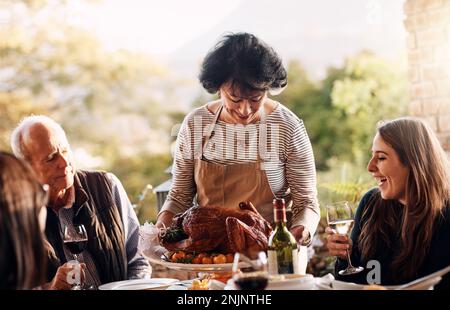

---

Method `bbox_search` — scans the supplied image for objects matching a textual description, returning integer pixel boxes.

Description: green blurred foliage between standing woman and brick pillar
[277,52,407,170]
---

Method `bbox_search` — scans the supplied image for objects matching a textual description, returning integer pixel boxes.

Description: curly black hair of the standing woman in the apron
[199,33,287,94]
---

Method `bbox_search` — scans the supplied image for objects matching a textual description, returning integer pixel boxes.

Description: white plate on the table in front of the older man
[98,278,179,290]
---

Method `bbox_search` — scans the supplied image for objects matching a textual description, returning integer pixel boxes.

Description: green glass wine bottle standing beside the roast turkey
[268,199,299,274]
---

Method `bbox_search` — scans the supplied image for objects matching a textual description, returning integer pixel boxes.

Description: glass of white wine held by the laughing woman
[327,201,364,275]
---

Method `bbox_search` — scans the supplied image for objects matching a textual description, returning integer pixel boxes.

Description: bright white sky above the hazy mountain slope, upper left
[69,0,241,55]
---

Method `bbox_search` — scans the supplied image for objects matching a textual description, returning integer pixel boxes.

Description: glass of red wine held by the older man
[63,224,88,290]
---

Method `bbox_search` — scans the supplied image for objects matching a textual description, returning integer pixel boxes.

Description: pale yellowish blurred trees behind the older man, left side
[0,0,181,221]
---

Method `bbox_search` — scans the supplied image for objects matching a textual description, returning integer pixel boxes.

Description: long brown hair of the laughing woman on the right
[358,117,450,281]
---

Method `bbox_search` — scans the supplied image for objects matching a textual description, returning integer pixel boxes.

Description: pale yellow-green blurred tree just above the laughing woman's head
[330,51,408,163]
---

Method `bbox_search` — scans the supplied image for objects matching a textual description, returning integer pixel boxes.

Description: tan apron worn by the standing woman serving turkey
[194,105,308,274]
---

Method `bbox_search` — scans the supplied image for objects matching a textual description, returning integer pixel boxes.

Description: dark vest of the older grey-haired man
[45,170,127,283]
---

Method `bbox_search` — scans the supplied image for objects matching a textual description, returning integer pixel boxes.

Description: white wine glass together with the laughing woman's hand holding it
[326,201,364,275]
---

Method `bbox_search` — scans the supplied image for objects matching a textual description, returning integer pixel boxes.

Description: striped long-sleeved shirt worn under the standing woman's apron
[161,103,320,235]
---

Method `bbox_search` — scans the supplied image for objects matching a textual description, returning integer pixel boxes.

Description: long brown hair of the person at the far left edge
[0,152,48,289]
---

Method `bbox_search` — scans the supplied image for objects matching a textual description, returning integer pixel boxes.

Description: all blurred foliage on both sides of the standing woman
[0,0,408,228]
